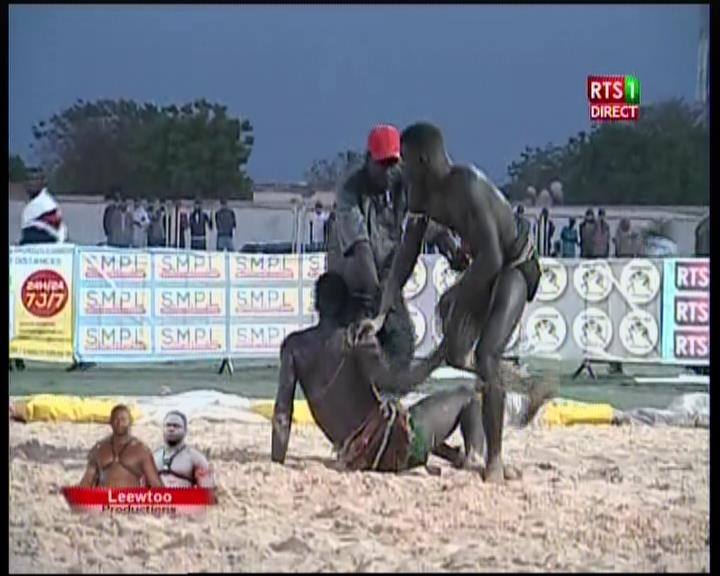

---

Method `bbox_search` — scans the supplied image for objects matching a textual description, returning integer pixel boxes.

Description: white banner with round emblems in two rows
[404,255,662,362]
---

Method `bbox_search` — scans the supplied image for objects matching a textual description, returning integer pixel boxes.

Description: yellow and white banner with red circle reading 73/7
[9,246,74,363]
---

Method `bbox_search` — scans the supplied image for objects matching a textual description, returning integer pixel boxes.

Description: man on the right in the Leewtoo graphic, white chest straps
[153,410,215,488]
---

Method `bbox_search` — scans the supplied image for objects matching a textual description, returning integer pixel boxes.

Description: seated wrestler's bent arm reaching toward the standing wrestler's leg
[355,336,444,394]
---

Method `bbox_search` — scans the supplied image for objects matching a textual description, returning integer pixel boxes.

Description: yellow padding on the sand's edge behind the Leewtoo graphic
[14,394,142,424]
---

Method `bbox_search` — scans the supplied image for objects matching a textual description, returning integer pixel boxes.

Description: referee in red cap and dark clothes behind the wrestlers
[328,124,461,369]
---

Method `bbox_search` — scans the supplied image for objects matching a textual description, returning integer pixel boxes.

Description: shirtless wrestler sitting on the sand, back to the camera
[272,272,483,472]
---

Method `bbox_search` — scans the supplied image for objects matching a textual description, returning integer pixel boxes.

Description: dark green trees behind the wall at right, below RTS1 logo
[506,100,710,205]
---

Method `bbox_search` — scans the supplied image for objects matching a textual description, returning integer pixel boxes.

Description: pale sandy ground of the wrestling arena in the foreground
[10,419,710,573]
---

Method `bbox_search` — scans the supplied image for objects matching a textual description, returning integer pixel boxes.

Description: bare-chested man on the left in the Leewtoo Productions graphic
[79,404,162,488]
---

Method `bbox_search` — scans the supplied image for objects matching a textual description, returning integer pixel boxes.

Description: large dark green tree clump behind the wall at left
[33,99,254,199]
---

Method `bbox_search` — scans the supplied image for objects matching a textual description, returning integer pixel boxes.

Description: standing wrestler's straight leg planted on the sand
[475,268,527,482]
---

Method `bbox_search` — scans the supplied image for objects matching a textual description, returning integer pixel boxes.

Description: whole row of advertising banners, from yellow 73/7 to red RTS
[9,246,688,364]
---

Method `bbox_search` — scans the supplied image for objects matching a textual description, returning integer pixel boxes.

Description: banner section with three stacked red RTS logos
[662,258,710,365]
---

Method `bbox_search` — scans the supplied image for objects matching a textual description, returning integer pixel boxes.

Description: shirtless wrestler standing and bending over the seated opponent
[366,123,541,482]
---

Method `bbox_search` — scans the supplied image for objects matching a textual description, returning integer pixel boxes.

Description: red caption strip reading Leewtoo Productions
[63,486,216,514]
